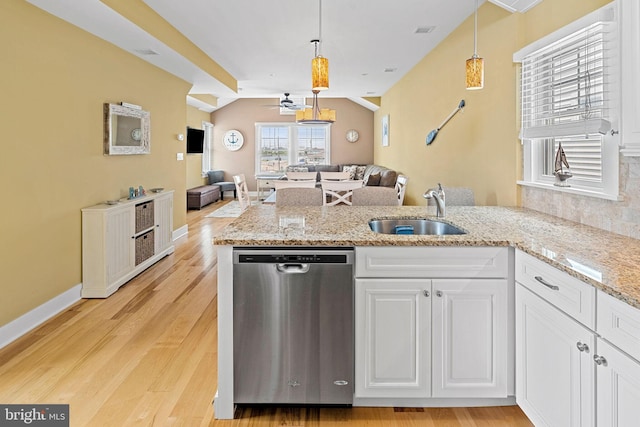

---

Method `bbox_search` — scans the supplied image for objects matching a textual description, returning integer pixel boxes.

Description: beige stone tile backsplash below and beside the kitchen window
[522,157,640,239]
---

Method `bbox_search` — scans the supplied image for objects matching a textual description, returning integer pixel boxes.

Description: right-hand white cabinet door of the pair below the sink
[432,279,508,397]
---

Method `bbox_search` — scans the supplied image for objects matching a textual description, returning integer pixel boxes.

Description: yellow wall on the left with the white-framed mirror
[0,0,190,325]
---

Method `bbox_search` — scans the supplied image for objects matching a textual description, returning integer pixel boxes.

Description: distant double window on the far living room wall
[256,123,331,174]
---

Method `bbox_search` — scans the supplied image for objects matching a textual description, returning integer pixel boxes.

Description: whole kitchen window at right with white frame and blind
[514,4,619,199]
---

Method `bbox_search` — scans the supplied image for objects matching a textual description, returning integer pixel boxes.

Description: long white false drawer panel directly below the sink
[356,246,509,279]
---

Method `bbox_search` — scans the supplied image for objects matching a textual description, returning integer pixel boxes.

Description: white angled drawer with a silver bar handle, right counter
[516,251,596,330]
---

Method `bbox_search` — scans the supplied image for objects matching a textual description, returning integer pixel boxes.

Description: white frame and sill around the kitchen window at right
[513,1,620,200]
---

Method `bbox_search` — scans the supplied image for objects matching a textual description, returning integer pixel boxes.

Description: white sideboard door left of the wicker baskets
[105,207,135,284]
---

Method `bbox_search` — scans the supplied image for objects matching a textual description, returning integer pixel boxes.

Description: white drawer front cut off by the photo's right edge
[596,290,640,360]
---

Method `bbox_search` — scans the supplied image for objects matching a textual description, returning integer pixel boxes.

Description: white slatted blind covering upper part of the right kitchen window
[520,22,615,140]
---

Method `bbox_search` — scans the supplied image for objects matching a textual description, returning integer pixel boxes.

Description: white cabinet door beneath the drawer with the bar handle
[516,284,595,427]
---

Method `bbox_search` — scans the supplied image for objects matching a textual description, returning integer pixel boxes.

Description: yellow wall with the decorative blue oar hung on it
[374,0,608,206]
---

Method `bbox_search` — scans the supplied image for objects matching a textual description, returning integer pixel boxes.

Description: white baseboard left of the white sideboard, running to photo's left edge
[0,284,82,348]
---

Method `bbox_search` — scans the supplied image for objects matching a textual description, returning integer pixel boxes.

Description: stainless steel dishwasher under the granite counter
[233,248,354,405]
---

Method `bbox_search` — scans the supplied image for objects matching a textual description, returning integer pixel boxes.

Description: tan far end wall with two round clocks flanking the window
[211,98,373,191]
